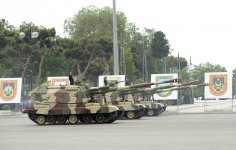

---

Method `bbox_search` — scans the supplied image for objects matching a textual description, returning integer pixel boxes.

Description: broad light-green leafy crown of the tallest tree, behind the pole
[64,6,127,41]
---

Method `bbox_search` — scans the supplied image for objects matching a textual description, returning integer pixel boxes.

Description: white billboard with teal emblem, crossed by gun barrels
[151,73,178,100]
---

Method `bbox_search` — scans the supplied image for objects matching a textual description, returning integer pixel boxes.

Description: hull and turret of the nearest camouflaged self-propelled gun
[23,83,119,125]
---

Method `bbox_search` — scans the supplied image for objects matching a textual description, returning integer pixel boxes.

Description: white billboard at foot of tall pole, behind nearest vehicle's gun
[98,75,125,87]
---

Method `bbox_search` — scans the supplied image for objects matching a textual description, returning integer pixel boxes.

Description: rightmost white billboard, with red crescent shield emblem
[205,72,232,99]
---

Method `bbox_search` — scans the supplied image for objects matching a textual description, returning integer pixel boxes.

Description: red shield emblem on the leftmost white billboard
[0,80,17,101]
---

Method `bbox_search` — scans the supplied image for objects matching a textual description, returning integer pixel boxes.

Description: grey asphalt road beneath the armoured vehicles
[0,114,236,150]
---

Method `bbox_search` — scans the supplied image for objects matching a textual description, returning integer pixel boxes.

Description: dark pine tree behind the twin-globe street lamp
[20,22,56,86]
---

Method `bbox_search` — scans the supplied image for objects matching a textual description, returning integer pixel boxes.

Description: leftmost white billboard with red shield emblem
[0,78,22,103]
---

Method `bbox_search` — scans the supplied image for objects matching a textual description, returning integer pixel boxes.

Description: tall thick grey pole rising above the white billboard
[113,0,120,75]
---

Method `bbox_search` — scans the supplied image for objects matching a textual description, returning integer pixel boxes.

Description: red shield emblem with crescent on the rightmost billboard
[209,74,227,96]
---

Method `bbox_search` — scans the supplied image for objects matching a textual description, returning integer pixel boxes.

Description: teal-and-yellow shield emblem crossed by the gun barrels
[156,76,173,97]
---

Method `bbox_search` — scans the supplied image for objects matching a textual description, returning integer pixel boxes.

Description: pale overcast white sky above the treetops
[0,0,236,72]
